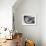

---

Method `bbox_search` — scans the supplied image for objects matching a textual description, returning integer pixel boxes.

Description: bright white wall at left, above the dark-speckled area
[0,0,16,29]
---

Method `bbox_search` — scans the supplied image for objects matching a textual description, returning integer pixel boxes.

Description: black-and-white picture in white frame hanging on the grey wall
[22,15,36,25]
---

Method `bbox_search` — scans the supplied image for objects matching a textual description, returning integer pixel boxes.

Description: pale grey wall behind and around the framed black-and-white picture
[13,0,41,46]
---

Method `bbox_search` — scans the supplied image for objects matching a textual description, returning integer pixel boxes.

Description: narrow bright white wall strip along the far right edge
[40,0,46,46]
